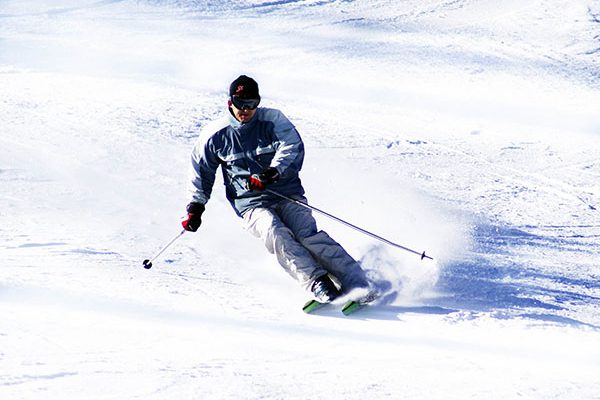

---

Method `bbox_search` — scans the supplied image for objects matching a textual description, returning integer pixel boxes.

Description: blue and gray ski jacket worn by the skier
[189,107,304,216]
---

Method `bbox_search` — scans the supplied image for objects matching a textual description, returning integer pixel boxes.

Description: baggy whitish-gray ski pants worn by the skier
[243,197,368,291]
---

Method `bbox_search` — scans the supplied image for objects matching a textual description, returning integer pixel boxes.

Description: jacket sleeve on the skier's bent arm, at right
[270,112,304,176]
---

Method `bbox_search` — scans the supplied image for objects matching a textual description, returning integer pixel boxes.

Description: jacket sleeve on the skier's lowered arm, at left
[188,134,219,204]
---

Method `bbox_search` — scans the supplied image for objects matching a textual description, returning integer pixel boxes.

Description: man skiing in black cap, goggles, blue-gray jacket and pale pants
[182,75,369,303]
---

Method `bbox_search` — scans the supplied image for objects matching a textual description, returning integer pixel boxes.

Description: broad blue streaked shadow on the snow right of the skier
[426,226,600,329]
